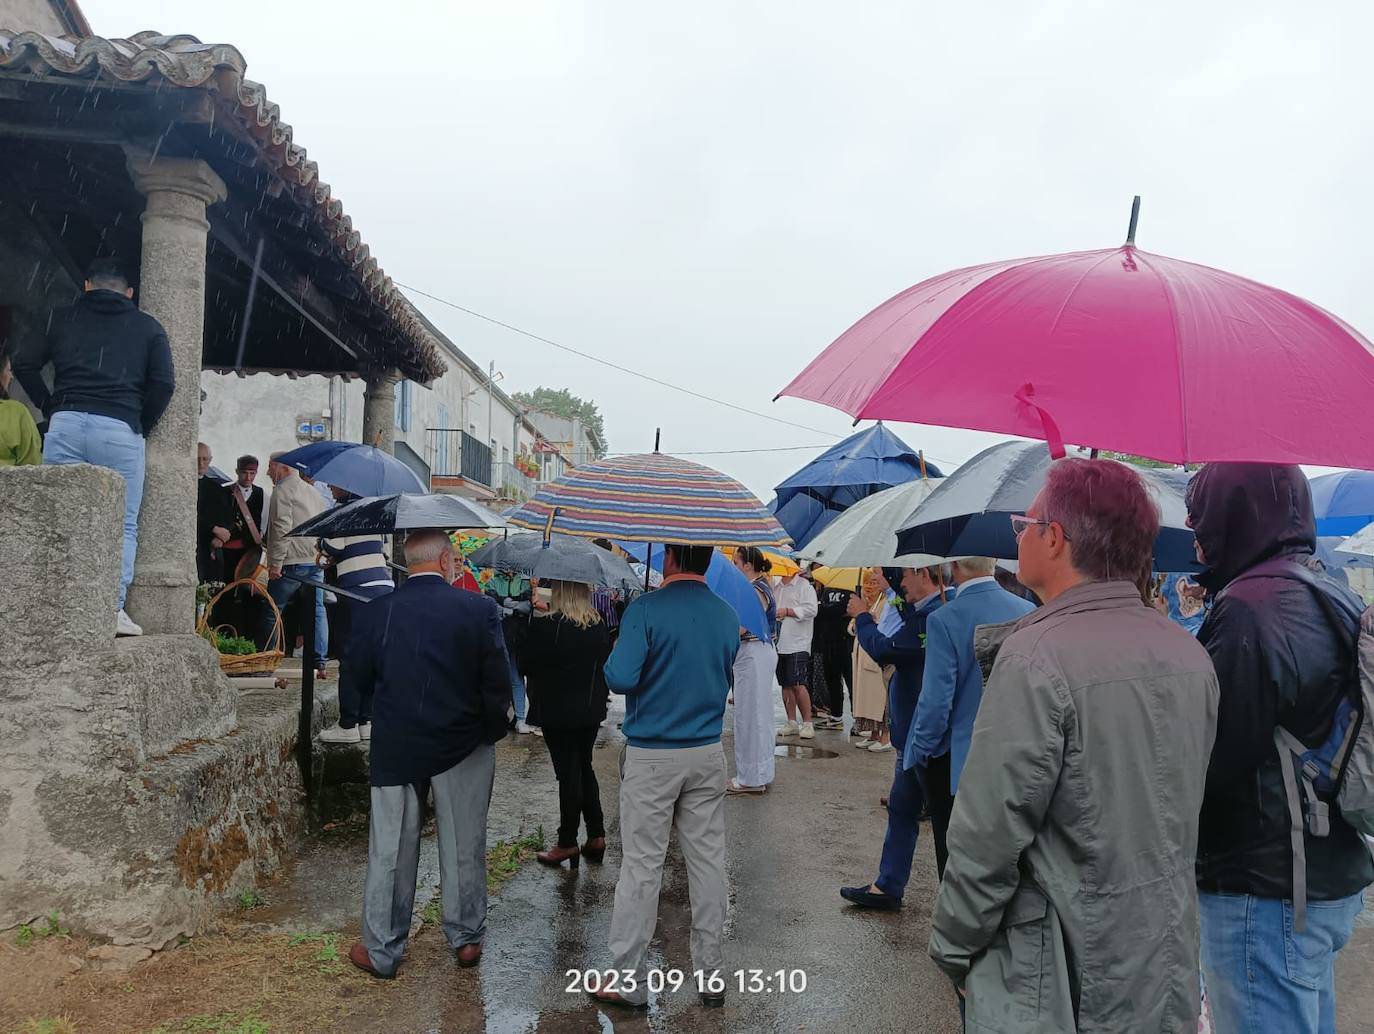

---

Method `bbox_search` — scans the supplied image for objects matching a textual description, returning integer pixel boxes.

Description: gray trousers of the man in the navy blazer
[363,743,496,974]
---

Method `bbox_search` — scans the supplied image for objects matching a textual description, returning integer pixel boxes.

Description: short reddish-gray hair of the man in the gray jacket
[1039,459,1160,582]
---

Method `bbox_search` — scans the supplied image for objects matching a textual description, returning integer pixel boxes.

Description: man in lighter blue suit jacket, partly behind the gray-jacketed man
[903,556,1035,879]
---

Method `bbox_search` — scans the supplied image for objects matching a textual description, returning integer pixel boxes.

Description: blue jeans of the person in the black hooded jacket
[1198,894,1364,1034]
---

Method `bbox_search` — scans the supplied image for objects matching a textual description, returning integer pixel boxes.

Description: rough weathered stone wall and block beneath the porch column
[0,466,330,947]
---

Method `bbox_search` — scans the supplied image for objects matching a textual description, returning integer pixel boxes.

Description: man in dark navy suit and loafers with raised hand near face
[840,564,949,912]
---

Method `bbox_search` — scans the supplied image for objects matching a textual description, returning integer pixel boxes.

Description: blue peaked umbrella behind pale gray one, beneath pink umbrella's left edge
[774,423,944,548]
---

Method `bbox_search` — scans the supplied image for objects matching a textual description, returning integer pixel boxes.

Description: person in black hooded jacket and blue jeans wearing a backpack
[1187,463,1374,1034]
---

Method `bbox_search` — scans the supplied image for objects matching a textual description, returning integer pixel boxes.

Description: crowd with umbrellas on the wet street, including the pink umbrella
[190,205,1374,1031]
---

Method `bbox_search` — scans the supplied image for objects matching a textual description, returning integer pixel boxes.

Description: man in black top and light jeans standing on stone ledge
[14,258,174,636]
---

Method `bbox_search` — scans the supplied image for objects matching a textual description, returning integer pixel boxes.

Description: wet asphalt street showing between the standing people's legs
[247,694,1374,1034]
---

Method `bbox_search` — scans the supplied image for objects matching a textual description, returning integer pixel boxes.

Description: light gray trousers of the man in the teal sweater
[610,743,728,1002]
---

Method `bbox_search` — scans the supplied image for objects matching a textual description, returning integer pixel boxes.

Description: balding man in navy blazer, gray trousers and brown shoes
[349,531,511,978]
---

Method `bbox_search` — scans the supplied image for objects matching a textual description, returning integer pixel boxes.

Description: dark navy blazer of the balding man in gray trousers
[349,575,511,787]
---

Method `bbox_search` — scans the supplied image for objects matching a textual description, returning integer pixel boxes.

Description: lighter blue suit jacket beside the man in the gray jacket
[903,582,1035,794]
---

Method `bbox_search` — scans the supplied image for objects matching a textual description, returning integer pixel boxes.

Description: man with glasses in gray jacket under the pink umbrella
[930,460,1219,1034]
